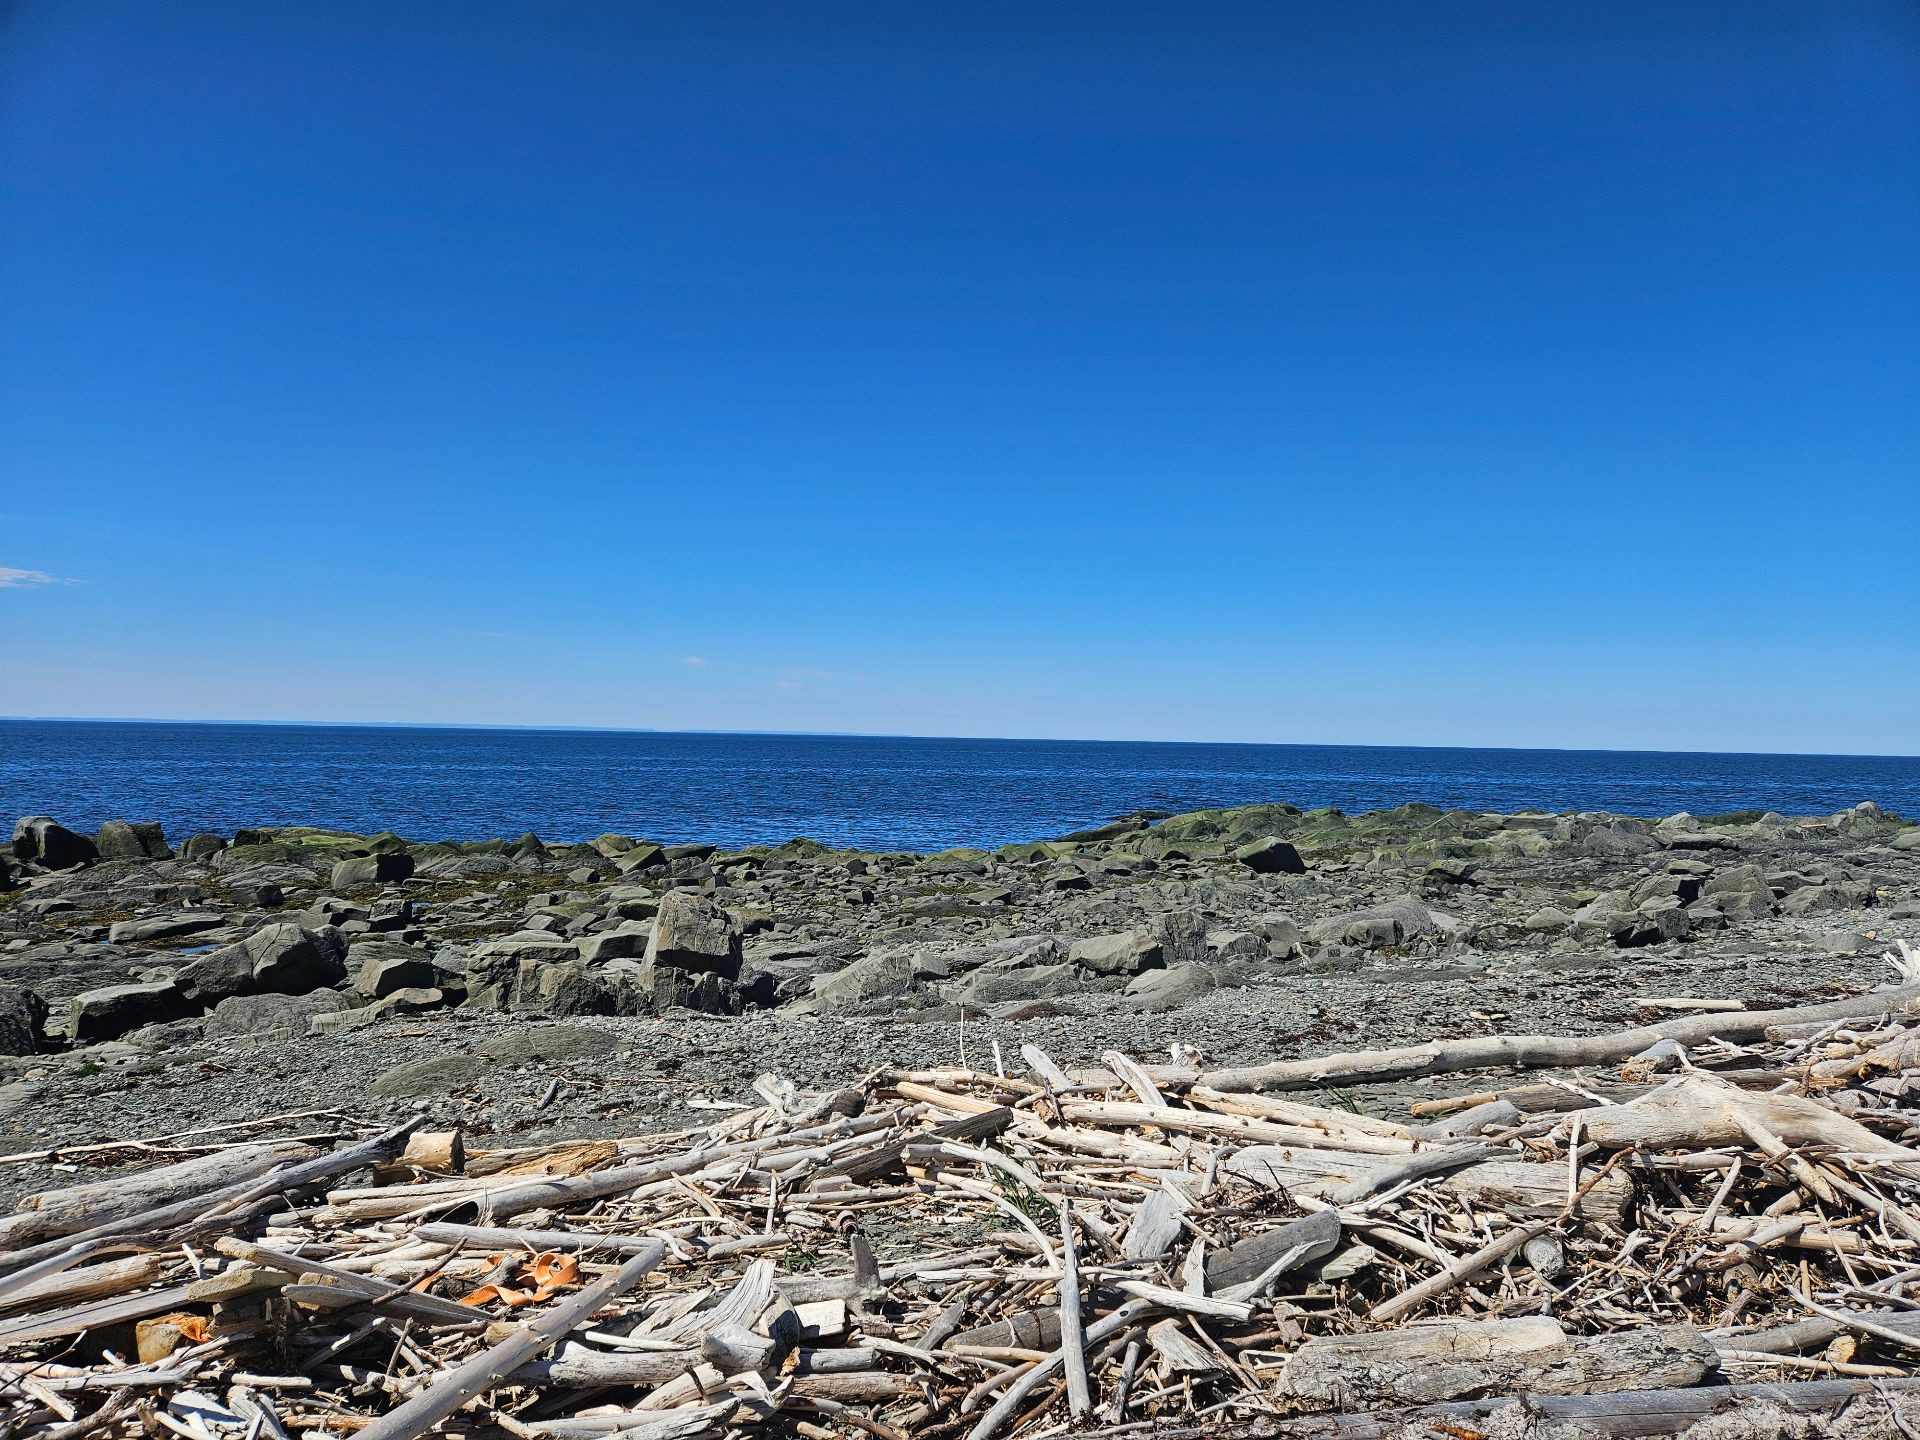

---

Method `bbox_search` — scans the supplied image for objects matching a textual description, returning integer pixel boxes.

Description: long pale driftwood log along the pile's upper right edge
[1196,985,1920,1091]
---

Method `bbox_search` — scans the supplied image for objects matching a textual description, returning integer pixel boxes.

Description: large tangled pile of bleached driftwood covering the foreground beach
[0,983,1920,1440]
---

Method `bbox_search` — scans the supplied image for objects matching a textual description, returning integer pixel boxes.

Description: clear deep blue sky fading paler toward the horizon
[0,0,1920,753]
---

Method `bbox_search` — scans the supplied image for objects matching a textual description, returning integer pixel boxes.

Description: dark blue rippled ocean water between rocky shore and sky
[0,720,1920,851]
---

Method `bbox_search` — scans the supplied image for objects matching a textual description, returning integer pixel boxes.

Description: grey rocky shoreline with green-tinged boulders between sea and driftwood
[0,803,1920,1188]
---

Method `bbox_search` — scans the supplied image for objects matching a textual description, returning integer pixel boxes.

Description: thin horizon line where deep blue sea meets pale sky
[0,714,1920,760]
